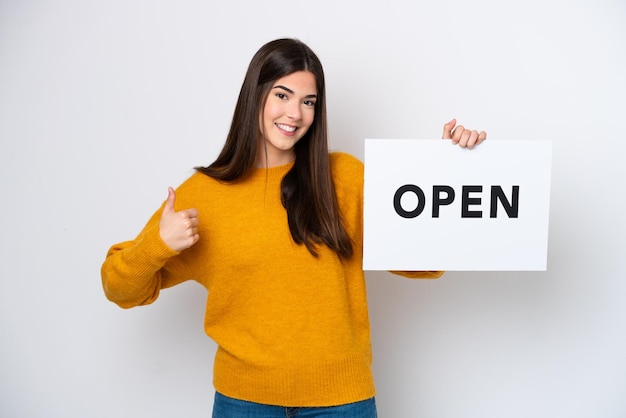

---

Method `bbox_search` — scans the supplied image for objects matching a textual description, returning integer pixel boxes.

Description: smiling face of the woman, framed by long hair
[257,71,317,167]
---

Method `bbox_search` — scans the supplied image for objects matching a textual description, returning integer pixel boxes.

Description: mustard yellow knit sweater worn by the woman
[102,153,441,406]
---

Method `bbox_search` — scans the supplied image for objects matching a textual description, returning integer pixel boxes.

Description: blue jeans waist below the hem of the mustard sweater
[213,392,378,418]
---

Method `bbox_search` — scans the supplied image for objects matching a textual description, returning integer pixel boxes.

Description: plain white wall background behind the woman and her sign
[0,0,626,418]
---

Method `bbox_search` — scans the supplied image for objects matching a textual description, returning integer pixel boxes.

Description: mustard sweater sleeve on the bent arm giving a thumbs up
[101,201,189,308]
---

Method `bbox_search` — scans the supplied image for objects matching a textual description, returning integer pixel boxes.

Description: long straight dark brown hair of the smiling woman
[196,39,353,259]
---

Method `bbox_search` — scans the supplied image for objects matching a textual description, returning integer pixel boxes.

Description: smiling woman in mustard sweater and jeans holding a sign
[102,39,486,418]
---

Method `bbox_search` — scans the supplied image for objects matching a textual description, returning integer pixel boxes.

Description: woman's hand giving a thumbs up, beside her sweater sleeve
[159,187,200,251]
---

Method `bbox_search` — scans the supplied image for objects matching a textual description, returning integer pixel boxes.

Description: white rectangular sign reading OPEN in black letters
[363,139,552,271]
